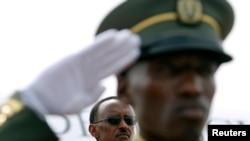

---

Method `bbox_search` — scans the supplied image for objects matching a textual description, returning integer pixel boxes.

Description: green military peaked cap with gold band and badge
[96,0,234,63]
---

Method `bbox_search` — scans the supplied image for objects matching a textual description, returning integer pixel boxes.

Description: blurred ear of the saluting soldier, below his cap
[117,75,133,105]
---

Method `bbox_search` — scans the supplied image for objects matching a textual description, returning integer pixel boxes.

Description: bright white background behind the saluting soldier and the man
[0,0,250,141]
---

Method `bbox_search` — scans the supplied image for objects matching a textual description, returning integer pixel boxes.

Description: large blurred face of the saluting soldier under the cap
[118,53,218,141]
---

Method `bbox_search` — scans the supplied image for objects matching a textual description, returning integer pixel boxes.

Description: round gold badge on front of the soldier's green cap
[177,0,202,24]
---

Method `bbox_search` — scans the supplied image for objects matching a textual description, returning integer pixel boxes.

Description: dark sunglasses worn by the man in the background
[94,115,136,126]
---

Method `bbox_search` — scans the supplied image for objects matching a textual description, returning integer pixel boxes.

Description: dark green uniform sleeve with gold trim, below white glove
[0,93,58,141]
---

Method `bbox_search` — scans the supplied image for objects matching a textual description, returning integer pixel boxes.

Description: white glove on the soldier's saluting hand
[21,30,141,115]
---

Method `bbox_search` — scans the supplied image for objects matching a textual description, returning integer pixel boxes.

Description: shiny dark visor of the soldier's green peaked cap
[140,35,232,63]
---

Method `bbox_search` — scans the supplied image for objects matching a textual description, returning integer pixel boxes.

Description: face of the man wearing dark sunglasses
[90,99,135,141]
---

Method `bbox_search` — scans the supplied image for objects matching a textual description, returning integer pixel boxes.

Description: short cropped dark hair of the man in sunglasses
[89,96,118,123]
